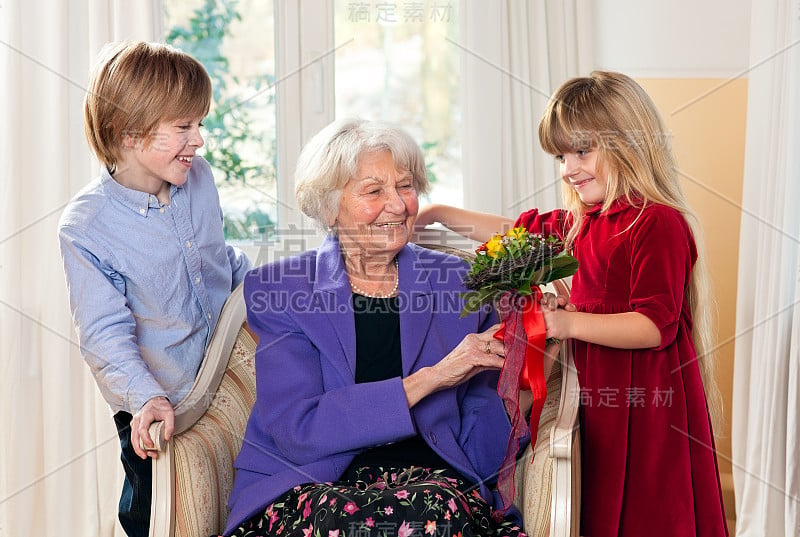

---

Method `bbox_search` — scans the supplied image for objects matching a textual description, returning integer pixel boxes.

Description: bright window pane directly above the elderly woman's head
[334,0,463,206]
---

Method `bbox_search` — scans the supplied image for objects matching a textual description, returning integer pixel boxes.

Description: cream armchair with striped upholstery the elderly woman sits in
[150,245,580,537]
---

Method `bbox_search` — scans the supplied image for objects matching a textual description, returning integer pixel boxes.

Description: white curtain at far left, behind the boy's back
[0,0,161,536]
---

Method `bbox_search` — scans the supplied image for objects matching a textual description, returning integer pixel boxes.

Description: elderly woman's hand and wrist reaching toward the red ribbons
[403,324,505,408]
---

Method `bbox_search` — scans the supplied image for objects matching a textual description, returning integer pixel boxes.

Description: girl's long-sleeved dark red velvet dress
[517,202,728,537]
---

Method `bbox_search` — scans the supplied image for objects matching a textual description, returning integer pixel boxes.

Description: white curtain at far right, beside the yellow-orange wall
[732,0,800,537]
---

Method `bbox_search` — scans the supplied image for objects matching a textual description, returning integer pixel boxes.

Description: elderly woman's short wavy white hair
[295,119,428,229]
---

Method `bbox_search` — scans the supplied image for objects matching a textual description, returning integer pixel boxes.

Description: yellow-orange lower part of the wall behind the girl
[638,79,747,519]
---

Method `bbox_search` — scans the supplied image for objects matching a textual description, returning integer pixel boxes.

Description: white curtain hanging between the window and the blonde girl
[462,0,593,217]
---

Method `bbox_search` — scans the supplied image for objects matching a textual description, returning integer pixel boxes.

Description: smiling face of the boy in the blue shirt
[113,118,204,202]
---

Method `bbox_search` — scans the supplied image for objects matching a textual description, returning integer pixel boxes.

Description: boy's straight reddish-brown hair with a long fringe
[83,41,211,172]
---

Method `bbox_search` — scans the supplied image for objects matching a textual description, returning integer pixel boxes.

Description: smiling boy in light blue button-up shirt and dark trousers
[58,42,250,536]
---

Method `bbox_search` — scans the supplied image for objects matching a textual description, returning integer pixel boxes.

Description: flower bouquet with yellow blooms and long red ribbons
[461,227,578,507]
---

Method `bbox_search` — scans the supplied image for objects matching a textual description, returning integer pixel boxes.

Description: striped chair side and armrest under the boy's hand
[148,285,255,537]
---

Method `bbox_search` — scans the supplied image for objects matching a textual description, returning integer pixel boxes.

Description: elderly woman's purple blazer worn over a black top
[225,236,510,534]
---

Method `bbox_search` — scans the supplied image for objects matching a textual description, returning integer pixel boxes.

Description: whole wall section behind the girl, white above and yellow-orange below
[592,0,751,532]
